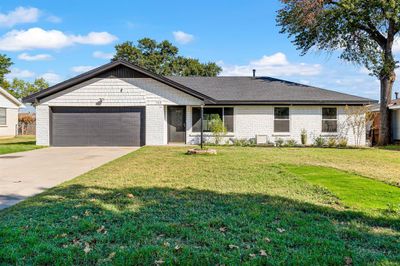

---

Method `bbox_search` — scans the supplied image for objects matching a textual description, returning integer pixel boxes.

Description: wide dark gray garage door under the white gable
[51,107,145,146]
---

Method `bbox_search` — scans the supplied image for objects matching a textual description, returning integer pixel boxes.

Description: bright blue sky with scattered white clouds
[0,0,390,99]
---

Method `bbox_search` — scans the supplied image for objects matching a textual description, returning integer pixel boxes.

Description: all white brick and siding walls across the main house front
[36,78,365,148]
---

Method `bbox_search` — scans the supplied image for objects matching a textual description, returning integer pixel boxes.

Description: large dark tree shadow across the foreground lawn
[0,185,400,265]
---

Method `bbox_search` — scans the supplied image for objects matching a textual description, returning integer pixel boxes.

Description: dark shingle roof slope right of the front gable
[167,76,374,104]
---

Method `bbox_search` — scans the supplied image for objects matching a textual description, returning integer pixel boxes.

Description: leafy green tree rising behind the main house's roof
[112,38,222,76]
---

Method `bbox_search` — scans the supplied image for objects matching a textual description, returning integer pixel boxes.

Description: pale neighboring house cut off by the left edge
[0,87,24,137]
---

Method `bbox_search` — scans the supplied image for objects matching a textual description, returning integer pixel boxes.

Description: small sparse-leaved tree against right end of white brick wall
[344,106,376,146]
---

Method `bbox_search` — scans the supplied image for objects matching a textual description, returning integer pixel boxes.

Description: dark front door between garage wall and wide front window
[167,106,186,143]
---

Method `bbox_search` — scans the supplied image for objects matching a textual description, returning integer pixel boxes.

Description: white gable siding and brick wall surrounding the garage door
[36,78,202,145]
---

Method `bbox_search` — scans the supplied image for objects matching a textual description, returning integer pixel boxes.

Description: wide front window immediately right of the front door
[192,107,233,132]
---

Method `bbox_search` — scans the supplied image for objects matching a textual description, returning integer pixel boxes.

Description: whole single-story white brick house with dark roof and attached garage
[24,61,374,146]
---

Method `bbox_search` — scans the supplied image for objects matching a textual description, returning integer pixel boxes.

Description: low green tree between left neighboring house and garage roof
[6,78,49,99]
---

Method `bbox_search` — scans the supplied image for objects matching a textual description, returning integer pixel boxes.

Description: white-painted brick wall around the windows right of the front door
[187,105,365,145]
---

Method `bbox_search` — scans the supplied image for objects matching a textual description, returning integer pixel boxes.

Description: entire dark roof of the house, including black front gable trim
[23,60,376,105]
